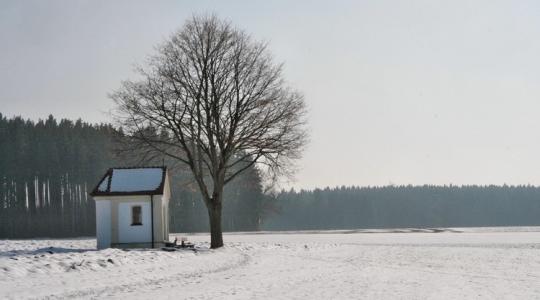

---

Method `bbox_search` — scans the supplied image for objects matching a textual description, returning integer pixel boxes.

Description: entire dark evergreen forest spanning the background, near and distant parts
[0,114,540,238]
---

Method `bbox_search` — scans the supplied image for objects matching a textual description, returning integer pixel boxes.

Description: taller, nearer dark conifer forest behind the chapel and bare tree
[0,114,269,238]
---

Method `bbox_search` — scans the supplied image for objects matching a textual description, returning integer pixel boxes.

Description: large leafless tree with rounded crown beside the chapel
[111,16,307,248]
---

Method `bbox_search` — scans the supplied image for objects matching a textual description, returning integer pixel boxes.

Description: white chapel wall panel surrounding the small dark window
[118,201,152,243]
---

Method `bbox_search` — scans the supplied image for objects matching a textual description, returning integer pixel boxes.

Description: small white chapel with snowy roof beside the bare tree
[90,167,171,249]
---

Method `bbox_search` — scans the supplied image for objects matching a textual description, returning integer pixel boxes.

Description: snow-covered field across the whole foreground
[0,228,540,299]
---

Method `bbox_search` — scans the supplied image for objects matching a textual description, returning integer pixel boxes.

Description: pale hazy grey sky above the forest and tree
[0,0,540,188]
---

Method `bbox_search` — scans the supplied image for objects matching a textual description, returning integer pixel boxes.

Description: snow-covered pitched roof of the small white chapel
[90,167,167,196]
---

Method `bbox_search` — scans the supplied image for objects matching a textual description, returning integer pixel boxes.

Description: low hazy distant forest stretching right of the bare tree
[263,185,540,230]
